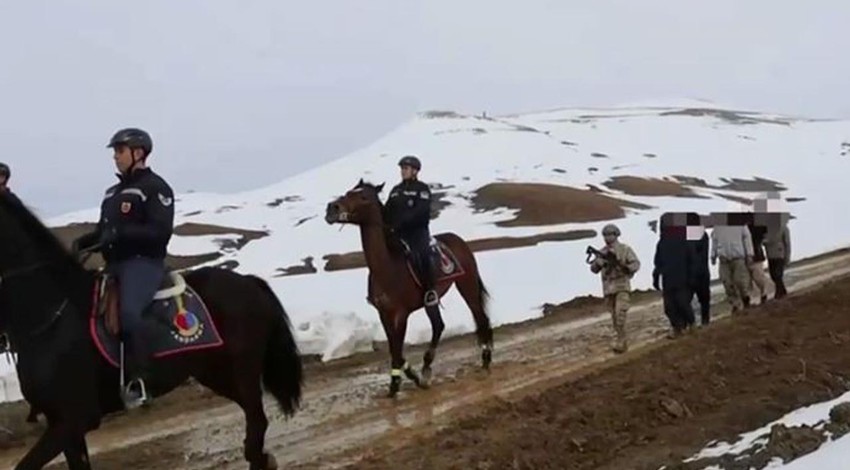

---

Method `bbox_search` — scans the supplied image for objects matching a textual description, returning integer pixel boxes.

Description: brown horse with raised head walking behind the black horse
[325,179,493,397]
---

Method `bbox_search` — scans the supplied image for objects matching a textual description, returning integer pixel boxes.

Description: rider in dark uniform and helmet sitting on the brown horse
[386,155,440,307]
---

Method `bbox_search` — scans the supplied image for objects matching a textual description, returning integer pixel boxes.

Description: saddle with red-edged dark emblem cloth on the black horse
[90,272,224,367]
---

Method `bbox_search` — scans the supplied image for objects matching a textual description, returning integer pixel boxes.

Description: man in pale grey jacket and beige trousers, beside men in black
[711,213,754,314]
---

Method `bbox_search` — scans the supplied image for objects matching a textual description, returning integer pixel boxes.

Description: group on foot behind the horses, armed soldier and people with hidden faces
[590,207,791,353]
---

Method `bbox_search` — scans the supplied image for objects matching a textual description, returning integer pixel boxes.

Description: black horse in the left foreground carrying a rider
[0,194,303,470]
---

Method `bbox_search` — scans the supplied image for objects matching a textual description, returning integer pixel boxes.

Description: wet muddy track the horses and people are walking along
[0,251,850,470]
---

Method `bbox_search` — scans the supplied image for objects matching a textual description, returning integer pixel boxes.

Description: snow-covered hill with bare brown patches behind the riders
[39,102,850,359]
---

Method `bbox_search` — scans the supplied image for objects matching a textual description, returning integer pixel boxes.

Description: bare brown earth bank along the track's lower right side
[350,277,850,470]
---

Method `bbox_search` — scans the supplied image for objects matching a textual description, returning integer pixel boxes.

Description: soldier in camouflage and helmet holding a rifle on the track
[590,224,640,354]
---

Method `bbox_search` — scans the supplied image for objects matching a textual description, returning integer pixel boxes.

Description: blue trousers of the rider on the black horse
[110,257,165,370]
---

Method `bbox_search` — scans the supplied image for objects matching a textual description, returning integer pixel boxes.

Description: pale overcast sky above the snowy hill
[0,0,850,215]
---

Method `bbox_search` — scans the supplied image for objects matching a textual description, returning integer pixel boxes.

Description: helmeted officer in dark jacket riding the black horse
[73,128,174,408]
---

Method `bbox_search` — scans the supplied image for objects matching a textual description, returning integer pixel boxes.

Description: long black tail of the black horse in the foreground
[249,275,304,416]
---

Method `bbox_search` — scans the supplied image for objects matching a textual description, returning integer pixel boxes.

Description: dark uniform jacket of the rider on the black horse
[77,168,174,264]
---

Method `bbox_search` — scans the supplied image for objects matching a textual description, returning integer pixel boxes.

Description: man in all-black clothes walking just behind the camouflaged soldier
[652,213,696,338]
